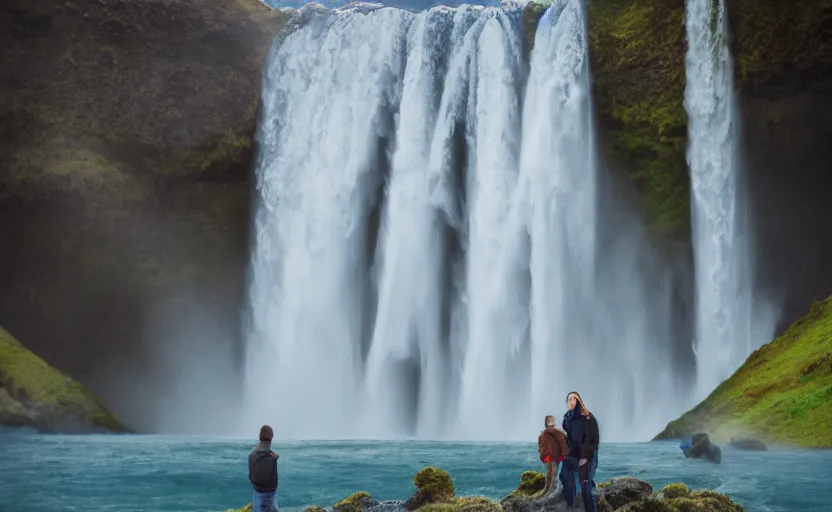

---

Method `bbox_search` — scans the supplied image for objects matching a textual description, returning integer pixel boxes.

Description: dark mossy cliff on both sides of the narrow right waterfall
[589,0,832,330]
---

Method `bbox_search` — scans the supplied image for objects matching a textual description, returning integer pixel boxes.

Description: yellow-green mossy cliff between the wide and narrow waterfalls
[589,0,690,239]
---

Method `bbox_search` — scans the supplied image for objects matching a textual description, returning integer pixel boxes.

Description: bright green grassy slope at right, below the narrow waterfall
[656,297,832,448]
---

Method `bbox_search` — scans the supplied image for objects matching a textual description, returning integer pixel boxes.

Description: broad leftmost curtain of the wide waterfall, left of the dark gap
[239,3,411,438]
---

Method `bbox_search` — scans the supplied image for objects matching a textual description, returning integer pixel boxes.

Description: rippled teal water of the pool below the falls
[0,433,832,512]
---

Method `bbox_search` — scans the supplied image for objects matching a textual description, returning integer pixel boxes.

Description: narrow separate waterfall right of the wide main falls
[685,0,773,401]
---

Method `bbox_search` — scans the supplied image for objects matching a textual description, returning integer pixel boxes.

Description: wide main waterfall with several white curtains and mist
[241,0,678,440]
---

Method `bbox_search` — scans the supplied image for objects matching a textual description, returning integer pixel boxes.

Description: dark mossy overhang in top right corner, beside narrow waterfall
[728,0,832,84]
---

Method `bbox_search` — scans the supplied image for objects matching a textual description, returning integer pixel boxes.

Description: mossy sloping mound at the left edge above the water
[0,328,126,432]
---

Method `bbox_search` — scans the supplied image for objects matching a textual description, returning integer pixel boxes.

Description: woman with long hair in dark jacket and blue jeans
[560,391,600,512]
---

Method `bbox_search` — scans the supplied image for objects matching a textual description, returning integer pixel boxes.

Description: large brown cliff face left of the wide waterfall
[0,0,285,428]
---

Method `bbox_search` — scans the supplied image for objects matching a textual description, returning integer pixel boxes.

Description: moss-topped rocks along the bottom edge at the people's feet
[228,467,744,512]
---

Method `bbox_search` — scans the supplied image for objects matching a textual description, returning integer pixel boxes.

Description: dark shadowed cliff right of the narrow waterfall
[727,0,832,331]
